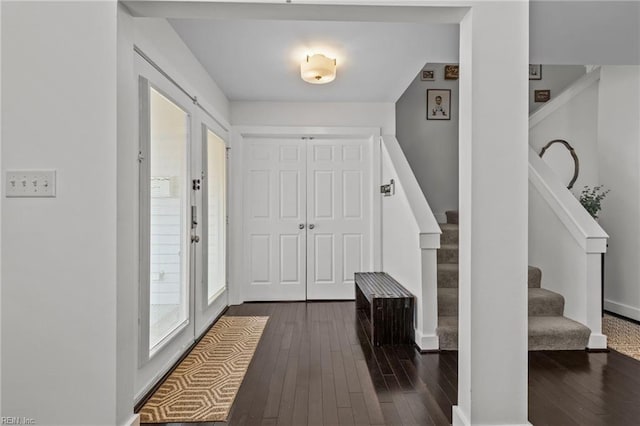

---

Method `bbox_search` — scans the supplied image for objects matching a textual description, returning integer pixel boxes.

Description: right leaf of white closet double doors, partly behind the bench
[307,139,371,300]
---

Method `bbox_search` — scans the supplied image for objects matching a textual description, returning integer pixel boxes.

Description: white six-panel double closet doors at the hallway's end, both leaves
[244,138,373,301]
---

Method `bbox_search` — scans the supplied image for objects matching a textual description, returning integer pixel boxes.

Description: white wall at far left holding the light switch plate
[1,1,117,425]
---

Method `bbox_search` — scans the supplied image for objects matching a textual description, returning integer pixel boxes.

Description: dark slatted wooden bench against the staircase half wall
[355,272,415,346]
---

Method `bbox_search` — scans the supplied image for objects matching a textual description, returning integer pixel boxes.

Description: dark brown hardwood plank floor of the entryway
[142,302,640,426]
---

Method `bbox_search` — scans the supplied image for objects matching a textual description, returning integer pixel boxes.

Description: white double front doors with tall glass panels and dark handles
[132,56,227,400]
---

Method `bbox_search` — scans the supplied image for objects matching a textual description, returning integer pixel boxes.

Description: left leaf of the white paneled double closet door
[244,138,307,300]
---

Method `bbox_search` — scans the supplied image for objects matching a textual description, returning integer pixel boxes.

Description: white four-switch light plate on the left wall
[5,170,56,198]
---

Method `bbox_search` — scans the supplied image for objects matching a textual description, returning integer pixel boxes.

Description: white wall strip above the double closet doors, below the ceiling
[231,102,396,135]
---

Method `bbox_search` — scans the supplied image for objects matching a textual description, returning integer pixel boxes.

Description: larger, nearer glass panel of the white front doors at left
[149,87,190,354]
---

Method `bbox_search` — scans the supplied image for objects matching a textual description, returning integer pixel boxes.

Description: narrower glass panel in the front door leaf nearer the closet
[206,129,227,304]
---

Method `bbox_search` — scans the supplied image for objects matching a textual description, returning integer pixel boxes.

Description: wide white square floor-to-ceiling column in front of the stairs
[453,1,529,426]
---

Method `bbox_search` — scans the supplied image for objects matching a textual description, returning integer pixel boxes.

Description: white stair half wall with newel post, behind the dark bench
[380,136,441,351]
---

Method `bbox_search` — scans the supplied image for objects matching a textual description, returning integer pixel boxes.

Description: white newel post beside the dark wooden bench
[416,233,440,351]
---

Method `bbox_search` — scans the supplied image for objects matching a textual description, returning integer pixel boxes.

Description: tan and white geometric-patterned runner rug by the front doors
[140,316,269,423]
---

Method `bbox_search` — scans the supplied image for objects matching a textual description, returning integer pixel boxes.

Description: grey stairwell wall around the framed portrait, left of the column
[396,64,459,223]
